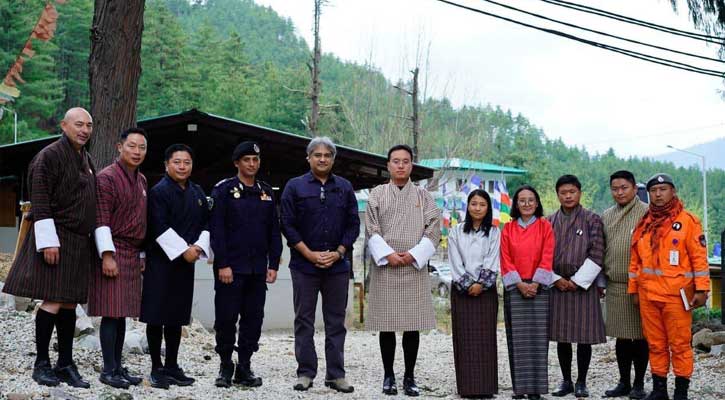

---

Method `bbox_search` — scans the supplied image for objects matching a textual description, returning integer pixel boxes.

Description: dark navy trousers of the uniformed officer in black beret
[214,274,267,366]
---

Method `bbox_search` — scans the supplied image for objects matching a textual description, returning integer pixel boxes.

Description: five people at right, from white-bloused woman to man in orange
[448,171,709,400]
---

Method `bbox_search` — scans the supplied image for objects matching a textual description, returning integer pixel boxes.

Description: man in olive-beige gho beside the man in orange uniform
[602,171,649,399]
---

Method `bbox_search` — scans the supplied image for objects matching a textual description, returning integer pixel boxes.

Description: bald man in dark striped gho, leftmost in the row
[3,108,96,388]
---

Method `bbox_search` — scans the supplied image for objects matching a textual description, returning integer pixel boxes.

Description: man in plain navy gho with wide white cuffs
[139,143,211,389]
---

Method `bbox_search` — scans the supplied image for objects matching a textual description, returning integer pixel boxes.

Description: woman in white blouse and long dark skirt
[448,189,500,398]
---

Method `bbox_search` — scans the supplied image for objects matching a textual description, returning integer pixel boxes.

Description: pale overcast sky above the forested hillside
[255,0,725,156]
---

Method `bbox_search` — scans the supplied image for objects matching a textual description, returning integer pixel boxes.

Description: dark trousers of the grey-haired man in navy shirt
[291,270,350,379]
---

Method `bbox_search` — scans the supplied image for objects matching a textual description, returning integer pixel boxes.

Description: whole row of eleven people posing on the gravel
[3,108,709,400]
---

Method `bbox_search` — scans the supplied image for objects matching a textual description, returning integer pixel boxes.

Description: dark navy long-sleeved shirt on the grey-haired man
[281,172,360,272]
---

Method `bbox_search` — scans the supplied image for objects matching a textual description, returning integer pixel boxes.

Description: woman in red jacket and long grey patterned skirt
[501,185,554,399]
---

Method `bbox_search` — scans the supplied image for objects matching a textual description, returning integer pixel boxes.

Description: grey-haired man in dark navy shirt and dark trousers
[281,137,360,393]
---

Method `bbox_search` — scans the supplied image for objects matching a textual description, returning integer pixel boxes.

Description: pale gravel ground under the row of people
[0,311,725,400]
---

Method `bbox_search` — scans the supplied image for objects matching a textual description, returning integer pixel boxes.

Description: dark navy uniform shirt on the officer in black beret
[209,177,282,274]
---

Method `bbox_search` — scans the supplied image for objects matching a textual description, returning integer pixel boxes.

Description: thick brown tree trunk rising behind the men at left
[88,0,145,169]
